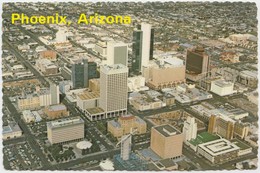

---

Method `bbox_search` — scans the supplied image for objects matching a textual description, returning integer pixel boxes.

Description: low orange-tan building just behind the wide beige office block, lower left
[44,104,69,119]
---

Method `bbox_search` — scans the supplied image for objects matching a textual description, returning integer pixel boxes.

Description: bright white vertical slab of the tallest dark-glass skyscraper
[141,23,152,66]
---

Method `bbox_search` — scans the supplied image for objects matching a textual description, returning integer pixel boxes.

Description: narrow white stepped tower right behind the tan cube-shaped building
[182,117,198,141]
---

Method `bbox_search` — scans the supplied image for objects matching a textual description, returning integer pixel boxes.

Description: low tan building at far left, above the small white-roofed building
[17,94,40,110]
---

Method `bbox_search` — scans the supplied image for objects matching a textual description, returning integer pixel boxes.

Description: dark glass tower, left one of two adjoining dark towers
[71,59,88,88]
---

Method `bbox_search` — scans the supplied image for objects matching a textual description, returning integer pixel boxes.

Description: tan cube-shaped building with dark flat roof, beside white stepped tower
[151,124,184,159]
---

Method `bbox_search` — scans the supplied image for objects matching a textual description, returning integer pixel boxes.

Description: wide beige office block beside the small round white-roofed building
[47,117,84,145]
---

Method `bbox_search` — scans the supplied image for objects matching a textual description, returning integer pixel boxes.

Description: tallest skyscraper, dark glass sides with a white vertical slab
[131,23,154,73]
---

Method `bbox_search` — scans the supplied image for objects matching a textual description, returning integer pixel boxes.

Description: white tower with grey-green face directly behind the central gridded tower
[107,41,128,66]
